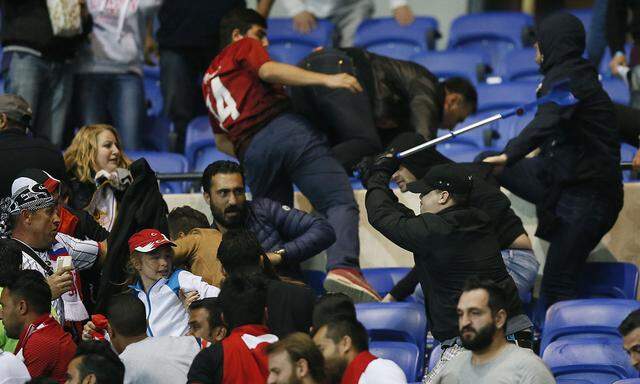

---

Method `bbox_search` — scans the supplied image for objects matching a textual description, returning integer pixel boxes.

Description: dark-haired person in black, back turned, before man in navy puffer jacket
[218,229,315,337]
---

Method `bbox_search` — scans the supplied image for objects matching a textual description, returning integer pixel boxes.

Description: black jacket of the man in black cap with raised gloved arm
[365,171,523,342]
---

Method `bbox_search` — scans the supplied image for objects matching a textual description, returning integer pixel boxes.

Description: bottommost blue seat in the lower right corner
[542,338,638,384]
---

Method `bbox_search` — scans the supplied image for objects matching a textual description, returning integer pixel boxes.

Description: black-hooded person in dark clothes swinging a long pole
[485,13,623,307]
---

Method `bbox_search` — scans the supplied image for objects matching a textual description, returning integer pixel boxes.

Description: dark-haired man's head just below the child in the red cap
[189,297,227,344]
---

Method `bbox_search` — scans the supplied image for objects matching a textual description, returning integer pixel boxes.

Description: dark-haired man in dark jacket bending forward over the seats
[292,48,478,173]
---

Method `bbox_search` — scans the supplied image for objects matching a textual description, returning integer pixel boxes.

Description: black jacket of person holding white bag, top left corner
[0,0,92,61]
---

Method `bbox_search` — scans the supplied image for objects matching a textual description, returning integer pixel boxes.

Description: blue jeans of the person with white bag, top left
[2,52,73,147]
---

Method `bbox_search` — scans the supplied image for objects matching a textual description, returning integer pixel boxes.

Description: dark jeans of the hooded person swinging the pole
[498,156,622,307]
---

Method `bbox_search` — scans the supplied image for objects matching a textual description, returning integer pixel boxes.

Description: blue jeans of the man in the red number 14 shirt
[243,113,360,270]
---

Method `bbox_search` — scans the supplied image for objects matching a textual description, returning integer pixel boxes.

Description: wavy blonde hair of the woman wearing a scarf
[64,124,131,183]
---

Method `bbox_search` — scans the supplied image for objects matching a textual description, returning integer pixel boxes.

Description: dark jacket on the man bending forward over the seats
[343,48,444,140]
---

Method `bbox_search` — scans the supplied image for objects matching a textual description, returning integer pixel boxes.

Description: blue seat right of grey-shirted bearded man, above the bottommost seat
[540,299,640,352]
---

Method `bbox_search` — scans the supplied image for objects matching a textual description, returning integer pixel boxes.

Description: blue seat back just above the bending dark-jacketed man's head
[411,51,487,84]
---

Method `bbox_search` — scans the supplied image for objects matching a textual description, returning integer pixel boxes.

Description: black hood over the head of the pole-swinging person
[536,12,586,74]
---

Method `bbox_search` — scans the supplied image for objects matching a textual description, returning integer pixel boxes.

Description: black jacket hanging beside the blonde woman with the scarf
[96,159,169,311]
